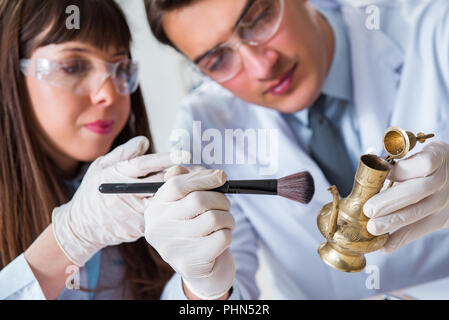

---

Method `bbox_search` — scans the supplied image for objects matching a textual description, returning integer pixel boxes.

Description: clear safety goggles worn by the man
[194,0,285,82]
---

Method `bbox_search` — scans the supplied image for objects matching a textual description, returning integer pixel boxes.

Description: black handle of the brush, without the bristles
[99,179,278,195]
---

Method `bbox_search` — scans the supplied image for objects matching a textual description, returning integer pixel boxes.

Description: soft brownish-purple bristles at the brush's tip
[278,171,315,203]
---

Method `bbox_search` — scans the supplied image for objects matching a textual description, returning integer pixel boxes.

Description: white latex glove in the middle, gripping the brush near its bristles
[145,169,235,299]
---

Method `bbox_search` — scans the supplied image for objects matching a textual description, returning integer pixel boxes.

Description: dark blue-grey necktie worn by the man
[309,95,355,197]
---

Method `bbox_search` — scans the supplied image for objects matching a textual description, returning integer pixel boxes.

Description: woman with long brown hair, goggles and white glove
[0,0,233,299]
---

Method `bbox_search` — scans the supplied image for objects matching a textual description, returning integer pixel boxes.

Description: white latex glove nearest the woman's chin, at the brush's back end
[52,137,180,267]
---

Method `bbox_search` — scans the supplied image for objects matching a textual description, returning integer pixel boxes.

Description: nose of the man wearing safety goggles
[239,44,279,80]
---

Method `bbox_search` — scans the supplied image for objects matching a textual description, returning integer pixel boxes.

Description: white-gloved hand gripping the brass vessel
[364,141,449,253]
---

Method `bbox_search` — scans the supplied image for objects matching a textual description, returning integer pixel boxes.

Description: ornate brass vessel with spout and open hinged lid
[317,127,433,272]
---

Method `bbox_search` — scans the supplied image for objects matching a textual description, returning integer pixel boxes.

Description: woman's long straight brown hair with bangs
[0,0,173,299]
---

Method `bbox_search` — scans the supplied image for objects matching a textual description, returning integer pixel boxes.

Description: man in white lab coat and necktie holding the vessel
[146,0,449,299]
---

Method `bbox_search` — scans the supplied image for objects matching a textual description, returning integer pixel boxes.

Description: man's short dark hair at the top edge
[144,0,197,49]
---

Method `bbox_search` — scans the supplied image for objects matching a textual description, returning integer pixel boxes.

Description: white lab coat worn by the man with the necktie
[166,0,449,299]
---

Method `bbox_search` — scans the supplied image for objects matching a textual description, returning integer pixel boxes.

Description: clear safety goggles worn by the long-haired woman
[20,57,139,95]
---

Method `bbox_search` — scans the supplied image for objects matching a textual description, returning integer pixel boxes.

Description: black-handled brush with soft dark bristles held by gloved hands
[99,171,315,203]
